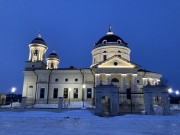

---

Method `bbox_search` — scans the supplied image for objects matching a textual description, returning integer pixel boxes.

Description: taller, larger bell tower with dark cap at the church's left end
[26,33,48,70]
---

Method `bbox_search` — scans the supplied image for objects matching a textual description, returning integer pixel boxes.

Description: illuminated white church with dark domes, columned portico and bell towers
[22,26,170,115]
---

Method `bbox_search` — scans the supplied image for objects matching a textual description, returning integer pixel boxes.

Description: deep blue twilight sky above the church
[0,0,180,93]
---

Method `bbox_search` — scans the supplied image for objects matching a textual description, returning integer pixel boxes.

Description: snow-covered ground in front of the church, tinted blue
[0,110,180,135]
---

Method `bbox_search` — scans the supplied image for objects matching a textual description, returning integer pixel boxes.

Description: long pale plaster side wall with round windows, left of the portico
[23,69,94,101]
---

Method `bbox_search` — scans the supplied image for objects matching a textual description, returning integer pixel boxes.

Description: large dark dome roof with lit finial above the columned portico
[94,26,128,49]
